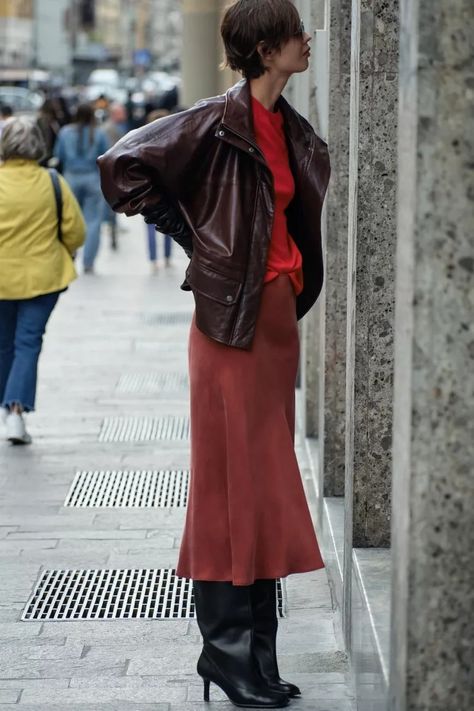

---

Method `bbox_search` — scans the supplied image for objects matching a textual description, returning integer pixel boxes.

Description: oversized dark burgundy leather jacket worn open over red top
[98,80,330,349]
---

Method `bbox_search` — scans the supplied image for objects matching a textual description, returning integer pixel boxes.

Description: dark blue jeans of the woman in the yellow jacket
[0,291,60,412]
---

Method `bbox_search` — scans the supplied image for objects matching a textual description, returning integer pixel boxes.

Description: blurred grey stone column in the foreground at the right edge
[389,0,474,711]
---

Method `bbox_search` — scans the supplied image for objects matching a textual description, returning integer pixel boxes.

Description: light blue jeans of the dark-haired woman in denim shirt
[64,172,104,269]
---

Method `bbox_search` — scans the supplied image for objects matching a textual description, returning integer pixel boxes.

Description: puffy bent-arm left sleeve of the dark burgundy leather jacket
[98,107,214,255]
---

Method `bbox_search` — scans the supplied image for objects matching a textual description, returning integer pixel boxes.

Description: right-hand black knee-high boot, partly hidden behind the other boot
[250,580,301,697]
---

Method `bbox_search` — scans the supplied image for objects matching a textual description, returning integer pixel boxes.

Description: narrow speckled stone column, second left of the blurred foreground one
[319,0,351,496]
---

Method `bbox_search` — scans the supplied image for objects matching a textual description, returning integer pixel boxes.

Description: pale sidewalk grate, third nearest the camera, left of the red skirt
[99,415,189,442]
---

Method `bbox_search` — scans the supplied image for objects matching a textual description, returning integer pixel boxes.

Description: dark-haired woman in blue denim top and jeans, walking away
[54,104,109,274]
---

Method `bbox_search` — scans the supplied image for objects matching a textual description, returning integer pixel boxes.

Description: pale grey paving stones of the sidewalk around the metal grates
[0,218,353,711]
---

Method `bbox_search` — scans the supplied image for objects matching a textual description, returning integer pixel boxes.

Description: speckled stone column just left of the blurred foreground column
[345,0,399,552]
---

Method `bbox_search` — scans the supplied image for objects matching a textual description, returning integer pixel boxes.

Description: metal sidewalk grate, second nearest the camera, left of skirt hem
[64,470,189,508]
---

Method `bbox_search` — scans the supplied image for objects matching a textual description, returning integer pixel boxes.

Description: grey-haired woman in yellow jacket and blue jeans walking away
[0,118,85,444]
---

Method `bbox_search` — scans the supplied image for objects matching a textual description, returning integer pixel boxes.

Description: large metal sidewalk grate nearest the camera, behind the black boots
[21,568,286,621]
